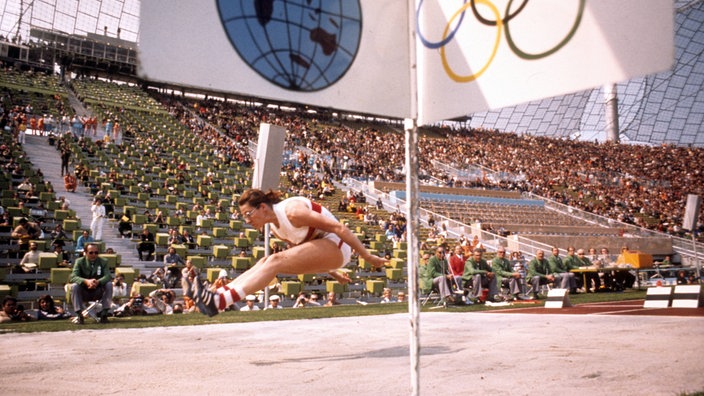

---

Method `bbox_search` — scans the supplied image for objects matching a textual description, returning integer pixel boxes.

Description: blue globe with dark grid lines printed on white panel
[216,0,362,92]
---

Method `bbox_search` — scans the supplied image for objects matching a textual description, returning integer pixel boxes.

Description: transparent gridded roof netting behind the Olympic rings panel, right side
[469,0,704,147]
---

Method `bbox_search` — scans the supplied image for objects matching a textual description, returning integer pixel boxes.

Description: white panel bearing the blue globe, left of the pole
[139,0,411,117]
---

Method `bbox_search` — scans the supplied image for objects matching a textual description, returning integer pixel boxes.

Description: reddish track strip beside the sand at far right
[485,300,704,316]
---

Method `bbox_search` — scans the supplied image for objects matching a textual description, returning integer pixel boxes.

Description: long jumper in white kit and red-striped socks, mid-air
[186,189,388,316]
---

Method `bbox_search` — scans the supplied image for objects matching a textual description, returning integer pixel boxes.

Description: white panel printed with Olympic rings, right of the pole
[416,0,674,124]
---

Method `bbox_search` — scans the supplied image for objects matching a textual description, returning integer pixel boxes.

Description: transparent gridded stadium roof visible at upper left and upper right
[0,0,704,147]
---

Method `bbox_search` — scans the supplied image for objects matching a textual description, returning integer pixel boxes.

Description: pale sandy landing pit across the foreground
[0,312,704,396]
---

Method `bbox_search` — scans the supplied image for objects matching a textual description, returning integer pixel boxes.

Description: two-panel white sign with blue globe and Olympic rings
[139,0,674,125]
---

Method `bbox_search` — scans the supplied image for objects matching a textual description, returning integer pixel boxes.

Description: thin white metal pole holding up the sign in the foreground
[405,119,420,395]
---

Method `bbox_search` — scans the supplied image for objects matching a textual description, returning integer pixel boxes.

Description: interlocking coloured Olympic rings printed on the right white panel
[416,0,586,82]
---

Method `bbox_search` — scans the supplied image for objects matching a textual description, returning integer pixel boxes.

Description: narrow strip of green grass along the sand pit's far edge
[0,290,645,333]
